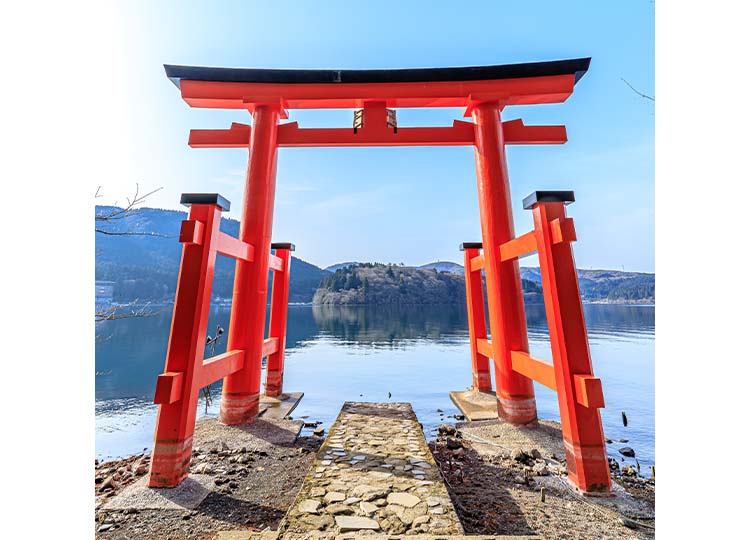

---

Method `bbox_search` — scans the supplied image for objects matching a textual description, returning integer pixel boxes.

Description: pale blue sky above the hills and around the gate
[103,0,654,271]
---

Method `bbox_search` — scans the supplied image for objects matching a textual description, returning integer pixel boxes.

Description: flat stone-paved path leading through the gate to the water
[278,402,464,539]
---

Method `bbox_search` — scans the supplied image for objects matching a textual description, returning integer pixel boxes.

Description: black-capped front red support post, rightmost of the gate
[524,192,611,493]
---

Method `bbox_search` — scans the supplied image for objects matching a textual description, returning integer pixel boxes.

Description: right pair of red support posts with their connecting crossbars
[464,191,611,495]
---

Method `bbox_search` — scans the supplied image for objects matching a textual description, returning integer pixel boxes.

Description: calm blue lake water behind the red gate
[96,305,654,470]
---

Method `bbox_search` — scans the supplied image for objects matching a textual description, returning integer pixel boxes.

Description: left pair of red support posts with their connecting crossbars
[149,193,294,487]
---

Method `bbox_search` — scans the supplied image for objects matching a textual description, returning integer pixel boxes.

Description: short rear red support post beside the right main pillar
[461,243,492,392]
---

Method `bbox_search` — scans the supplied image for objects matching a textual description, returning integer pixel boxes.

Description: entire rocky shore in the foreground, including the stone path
[94,414,655,540]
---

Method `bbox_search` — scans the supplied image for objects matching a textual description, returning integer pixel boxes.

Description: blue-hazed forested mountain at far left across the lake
[96,206,329,302]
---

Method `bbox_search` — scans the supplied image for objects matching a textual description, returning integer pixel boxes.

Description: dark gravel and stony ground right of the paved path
[430,422,655,540]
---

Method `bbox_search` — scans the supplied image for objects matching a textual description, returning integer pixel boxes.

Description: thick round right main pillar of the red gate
[472,102,536,424]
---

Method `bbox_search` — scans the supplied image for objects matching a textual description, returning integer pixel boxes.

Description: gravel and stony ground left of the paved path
[95,422,322,540]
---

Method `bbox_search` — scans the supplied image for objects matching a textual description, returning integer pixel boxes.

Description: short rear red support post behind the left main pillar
[266,244,294,397]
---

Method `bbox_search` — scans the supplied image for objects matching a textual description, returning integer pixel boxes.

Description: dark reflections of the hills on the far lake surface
[96,305,654,400]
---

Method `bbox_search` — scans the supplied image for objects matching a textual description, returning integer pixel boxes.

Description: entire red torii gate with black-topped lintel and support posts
[149,58,610,493]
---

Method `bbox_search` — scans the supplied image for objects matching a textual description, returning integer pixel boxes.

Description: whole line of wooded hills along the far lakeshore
[95,206,655,303]
